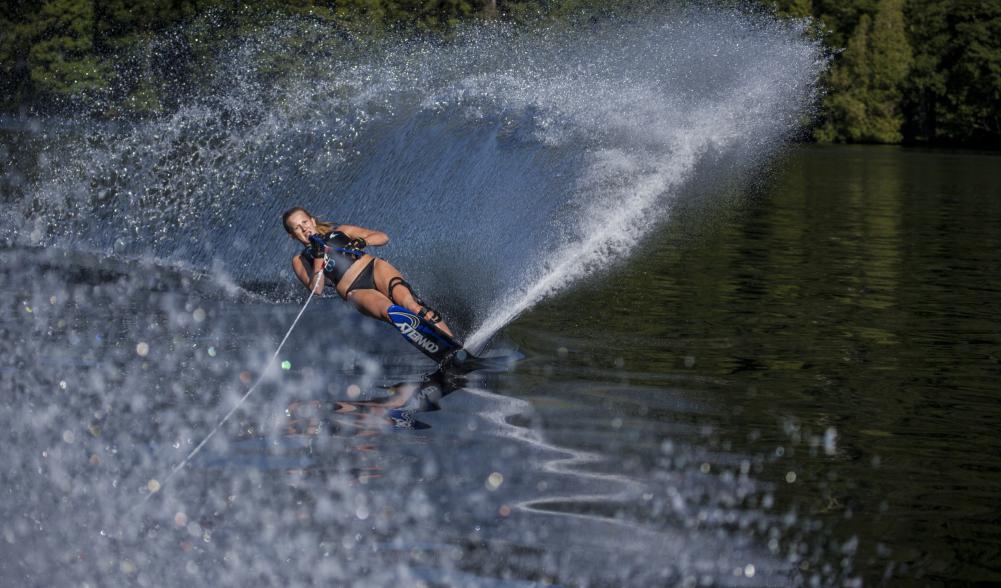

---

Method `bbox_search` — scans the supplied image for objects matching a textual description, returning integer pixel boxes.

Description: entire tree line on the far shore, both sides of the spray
[0,0,1001,148]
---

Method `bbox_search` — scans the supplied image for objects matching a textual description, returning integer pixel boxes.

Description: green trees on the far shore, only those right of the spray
[776,0,1001,148]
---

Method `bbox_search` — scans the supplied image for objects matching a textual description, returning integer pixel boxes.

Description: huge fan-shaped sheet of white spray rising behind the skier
[4,9,824,349]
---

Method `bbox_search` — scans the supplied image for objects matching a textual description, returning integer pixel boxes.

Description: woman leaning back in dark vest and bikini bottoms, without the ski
[281,206,453,337]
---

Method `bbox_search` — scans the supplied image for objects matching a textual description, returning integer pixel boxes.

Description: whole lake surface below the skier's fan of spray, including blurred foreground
[0,147,1001,586]
